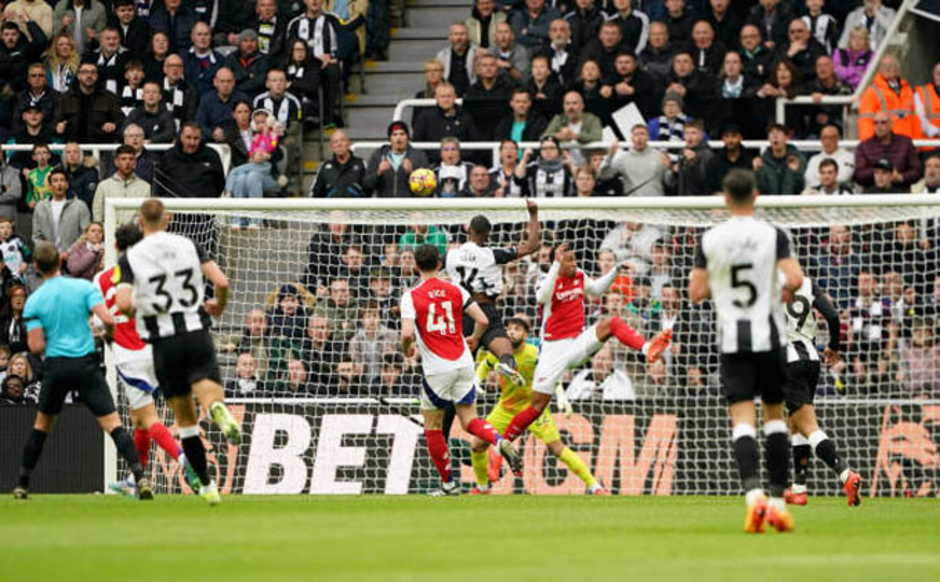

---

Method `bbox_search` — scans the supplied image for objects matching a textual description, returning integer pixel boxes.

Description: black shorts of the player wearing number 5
[720,349,787,404]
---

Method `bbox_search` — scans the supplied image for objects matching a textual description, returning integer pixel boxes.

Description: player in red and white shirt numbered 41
[401,245,522,495]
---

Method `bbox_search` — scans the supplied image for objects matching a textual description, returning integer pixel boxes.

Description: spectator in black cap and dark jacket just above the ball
[365,121,429,198]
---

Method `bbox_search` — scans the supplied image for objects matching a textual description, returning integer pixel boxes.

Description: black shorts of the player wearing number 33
[152,329,222,398]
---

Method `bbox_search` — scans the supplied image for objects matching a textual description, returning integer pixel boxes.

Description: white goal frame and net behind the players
[106,195,940,496]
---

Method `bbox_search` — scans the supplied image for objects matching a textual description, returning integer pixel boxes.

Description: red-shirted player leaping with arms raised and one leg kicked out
[503,244,672,460]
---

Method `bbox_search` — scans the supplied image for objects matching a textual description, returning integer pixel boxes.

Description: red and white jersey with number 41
[401,277,473,376]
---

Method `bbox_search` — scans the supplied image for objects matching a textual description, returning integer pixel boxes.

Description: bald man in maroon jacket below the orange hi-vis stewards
[855,111,921,190]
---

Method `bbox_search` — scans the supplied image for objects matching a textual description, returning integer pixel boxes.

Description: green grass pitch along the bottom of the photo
[0,495,940,582]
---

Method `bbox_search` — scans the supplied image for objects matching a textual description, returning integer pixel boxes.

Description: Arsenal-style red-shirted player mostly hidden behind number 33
[94,224,200,496]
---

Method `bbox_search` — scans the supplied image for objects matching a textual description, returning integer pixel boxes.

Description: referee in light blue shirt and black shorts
[13,242,153,499]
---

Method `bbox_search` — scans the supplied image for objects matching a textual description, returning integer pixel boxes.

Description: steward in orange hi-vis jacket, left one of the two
[858,55,920,143]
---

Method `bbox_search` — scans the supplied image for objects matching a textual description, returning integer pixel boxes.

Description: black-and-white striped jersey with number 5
[695,216,790,354]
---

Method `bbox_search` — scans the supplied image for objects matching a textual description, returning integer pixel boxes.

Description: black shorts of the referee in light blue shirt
[39,354,116,417]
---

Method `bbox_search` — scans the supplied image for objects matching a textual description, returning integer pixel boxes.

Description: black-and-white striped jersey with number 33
[118,231,210,342]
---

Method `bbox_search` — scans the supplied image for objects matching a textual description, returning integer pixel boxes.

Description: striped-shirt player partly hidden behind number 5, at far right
[783,277,862,507]
